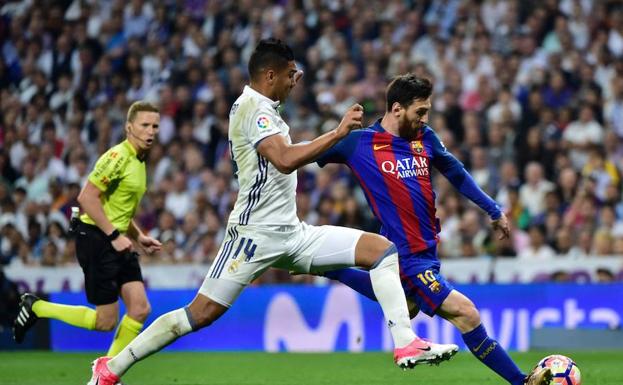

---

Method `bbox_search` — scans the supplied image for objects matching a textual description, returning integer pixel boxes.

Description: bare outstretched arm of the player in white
[257,104,363,174]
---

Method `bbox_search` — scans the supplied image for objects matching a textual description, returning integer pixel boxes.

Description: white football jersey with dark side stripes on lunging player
[228,86,299,225]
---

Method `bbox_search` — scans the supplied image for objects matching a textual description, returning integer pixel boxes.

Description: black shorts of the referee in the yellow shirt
[76,221,143,305]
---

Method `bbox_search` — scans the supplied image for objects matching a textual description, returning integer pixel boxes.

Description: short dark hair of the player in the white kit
[249,37,294,80]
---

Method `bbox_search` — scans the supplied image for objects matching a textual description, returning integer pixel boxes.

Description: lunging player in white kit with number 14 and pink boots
[89,39,456,385]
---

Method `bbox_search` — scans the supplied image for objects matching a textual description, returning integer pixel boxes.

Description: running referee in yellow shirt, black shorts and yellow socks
[13,101,161,356]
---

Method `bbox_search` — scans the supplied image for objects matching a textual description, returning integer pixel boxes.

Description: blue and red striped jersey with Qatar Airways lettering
[316,120,501,256]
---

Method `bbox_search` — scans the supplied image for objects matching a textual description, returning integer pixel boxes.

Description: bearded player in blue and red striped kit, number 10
[317,74,551,385]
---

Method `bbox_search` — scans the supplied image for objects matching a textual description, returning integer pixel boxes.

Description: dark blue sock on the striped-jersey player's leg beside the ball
[462,324,526,385]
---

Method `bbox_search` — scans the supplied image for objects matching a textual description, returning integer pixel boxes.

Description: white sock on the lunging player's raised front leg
[370,246,416,348]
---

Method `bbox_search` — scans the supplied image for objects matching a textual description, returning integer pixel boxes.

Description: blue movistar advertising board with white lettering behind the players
[51,284,623,352]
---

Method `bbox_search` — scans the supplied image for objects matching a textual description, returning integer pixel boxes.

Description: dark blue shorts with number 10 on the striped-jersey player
[399,247,454,317]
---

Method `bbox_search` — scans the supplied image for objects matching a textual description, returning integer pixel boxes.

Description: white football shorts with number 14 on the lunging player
[199,222,363,307]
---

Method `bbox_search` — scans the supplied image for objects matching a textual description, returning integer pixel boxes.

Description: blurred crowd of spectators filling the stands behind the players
[0,0,623,282]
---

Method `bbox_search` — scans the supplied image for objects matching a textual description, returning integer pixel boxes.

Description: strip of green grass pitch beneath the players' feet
[0,350,623,385]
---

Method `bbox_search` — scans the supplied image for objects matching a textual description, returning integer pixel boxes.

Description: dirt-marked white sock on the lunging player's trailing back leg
[108,308,193,376]
